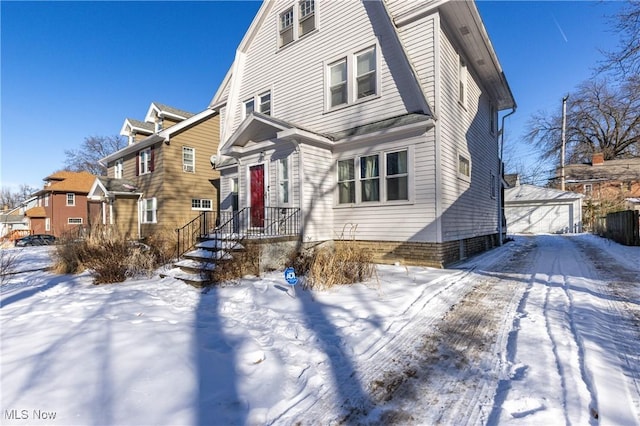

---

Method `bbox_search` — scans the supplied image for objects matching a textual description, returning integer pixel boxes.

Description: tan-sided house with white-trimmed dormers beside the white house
[90,102,219,239]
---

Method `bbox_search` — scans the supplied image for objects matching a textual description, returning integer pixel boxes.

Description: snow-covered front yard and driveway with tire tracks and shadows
[0,235,640,425]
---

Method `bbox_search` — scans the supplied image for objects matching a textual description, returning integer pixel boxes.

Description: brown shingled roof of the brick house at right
[558,158,640,183]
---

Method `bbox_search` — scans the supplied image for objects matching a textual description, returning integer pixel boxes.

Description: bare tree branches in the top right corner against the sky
[599,0,640,75]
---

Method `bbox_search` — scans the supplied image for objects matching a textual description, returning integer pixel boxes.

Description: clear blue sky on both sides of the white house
[0,0,621,189]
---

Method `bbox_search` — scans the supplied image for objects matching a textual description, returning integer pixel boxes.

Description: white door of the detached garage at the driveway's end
[506,204,573,234]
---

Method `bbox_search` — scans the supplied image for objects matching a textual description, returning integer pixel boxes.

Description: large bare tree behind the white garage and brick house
[526,75,640,163]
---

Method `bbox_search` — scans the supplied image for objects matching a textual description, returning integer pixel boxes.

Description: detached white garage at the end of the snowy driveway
[504,185,584,234]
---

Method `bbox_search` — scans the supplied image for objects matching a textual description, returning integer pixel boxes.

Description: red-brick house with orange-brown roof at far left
[24,171,96,237]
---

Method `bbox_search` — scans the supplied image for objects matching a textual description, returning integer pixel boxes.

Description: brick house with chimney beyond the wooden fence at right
[558,153,640,229]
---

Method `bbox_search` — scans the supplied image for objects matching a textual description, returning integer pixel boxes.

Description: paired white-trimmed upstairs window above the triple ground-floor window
[326,46,379,109]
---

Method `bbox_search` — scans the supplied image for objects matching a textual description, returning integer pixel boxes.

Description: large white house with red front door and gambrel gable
[210,0,515,266]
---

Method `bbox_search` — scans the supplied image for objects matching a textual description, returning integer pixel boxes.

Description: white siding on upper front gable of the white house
[230,1,424,137]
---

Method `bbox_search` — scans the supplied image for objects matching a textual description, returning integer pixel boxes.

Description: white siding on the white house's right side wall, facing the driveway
[439,28,499,241]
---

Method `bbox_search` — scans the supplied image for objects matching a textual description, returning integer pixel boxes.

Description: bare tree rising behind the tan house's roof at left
[64,136,126,176]
